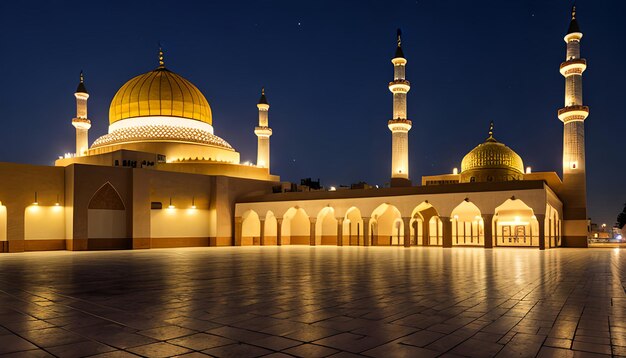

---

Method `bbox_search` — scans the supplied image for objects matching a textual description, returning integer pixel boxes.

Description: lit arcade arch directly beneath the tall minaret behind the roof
[370,204,404,246]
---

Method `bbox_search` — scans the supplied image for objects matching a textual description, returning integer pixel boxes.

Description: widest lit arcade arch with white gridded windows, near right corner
[493,198,539,246]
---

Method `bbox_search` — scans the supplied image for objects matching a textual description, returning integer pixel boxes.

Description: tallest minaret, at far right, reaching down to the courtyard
[558,6,589,246]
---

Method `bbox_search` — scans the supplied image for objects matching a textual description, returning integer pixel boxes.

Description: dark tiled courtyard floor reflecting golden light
[0,247,626,357]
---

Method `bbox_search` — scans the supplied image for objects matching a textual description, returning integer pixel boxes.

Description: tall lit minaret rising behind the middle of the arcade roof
[387,29,412,186]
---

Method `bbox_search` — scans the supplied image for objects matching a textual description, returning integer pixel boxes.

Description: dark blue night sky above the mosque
[0,0,626,225]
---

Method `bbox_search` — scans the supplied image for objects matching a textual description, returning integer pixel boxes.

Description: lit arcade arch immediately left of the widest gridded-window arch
[451,200,485,246]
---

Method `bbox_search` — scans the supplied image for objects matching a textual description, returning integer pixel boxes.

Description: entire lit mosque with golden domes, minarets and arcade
[0,8,589,252]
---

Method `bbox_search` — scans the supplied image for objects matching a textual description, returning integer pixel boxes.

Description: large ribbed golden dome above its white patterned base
[109,65,213,124]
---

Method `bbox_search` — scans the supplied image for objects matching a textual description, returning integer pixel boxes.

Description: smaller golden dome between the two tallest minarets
[461,123,524,182]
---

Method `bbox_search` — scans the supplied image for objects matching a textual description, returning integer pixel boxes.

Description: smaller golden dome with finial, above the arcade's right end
[461,122,524,181]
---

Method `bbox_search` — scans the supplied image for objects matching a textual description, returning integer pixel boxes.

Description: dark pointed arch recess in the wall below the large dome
[87,182,131,250]
